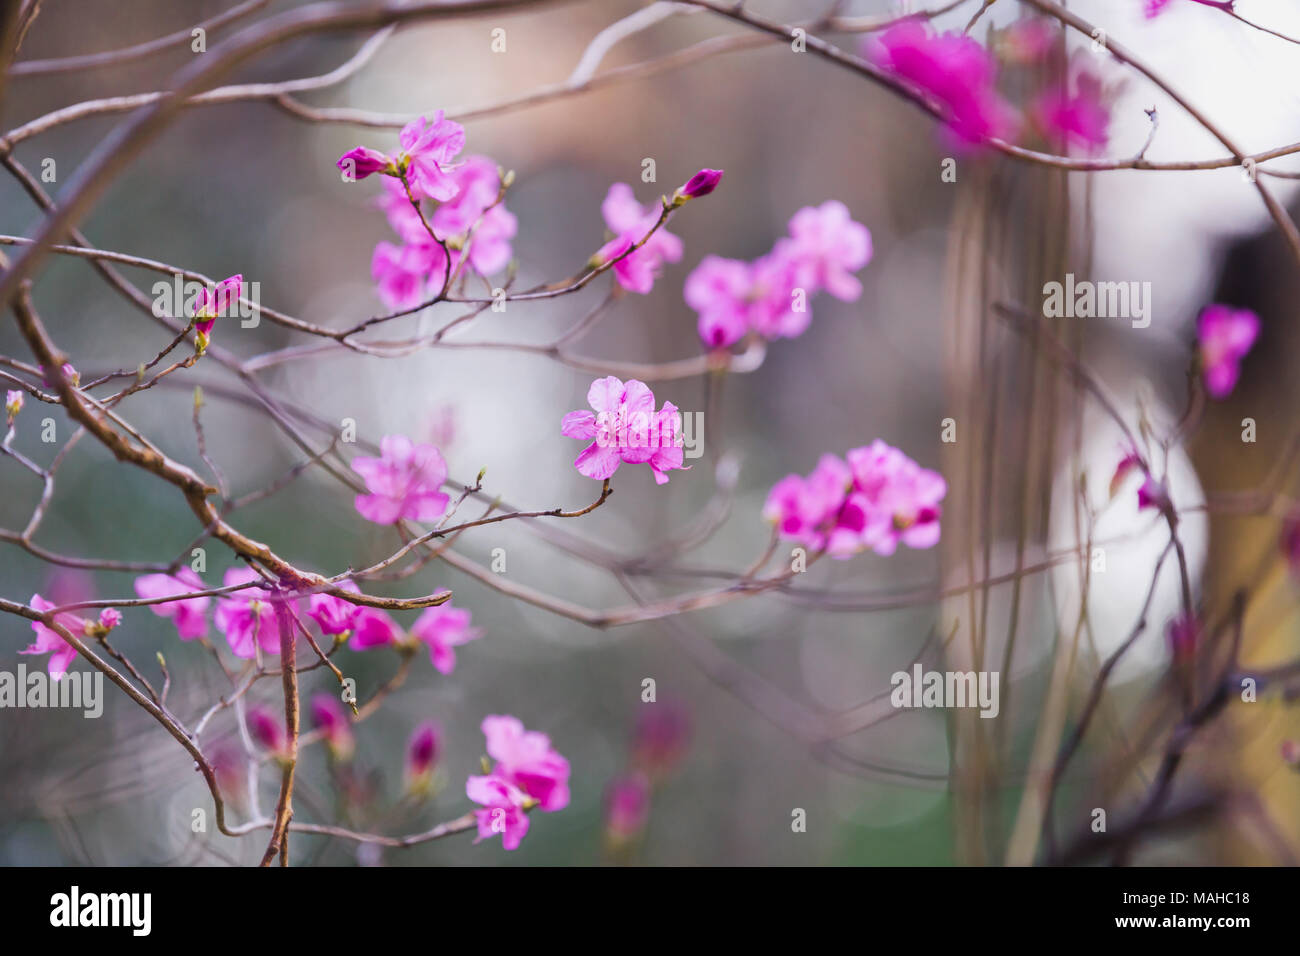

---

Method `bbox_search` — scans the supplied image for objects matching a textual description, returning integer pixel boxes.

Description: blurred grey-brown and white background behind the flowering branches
[0,0,1300,865]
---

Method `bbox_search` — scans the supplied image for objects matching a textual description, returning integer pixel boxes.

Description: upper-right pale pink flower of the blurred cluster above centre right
[785,199,871,302]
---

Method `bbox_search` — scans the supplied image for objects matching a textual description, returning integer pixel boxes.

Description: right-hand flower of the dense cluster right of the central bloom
[846,441,948,554]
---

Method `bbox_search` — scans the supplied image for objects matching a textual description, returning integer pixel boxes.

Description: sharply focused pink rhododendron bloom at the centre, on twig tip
[560,375,685,485]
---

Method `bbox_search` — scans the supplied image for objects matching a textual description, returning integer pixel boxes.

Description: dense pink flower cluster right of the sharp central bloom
[763,441,948,558]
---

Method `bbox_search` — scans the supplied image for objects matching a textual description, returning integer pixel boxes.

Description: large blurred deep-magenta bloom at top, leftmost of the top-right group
[863,20,1015,144]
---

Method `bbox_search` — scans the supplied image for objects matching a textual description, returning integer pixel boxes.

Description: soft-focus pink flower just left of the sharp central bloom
[352,434,451,524]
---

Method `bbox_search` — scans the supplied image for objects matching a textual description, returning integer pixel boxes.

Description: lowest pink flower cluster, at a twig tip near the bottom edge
[465,714,569,849]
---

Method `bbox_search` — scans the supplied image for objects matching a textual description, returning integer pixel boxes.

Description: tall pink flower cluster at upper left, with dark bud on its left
[337,109,519,310]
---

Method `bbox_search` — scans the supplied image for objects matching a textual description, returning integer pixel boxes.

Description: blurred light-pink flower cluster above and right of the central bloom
[683,199,871,349]
